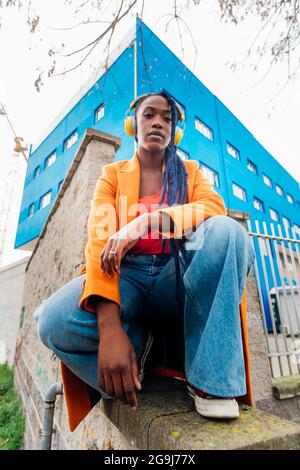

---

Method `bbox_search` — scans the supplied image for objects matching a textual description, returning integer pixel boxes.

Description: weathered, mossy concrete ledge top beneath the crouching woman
[100,376,300,450]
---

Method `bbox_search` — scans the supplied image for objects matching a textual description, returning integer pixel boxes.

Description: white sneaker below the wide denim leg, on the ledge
[187,385,240,419]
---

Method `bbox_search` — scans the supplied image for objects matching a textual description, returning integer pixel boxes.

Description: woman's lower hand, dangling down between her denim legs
[98,325,141,409]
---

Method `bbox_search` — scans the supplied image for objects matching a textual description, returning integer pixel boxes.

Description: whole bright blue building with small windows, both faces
[15,18,300,322]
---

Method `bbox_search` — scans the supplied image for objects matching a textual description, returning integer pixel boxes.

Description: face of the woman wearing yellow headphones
[136,95,172,152]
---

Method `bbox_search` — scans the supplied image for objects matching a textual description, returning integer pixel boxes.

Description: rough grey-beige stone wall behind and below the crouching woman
[15,129,282,450]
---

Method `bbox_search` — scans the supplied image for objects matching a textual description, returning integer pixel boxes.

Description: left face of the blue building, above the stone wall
[15,23,134,250]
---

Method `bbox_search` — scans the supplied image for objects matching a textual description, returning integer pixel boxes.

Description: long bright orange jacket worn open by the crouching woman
[61,151,252,431]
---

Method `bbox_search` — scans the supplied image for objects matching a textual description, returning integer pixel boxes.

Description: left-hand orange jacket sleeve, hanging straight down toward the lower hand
[78,164,120,313]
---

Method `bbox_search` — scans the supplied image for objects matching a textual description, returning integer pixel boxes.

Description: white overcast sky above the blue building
[0,0,300,265]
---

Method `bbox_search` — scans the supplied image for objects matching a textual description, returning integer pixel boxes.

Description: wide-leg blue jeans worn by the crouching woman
[34,215,254,398]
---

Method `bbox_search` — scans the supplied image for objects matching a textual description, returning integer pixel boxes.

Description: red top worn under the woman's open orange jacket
[127,188,171,255]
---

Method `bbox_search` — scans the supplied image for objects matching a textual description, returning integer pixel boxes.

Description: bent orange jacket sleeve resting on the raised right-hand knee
[158,161,227,238]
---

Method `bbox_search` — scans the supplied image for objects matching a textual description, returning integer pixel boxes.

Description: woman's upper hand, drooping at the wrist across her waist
[100,213,150,277]
